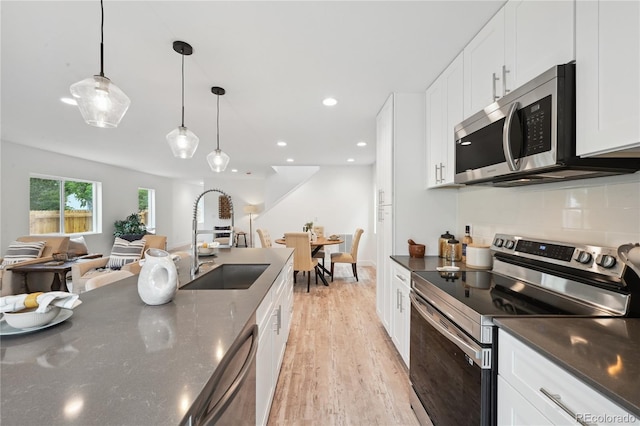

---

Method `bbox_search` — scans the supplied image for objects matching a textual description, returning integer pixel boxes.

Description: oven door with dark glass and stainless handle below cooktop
[409,291,495,426]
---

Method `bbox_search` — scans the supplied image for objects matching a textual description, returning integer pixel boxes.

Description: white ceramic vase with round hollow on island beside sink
[138,248,178,305]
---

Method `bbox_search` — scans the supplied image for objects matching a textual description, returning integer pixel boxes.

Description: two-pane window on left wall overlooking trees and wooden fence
[29,176,102,235]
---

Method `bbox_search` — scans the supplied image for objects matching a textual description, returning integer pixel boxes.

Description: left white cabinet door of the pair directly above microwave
[464,8,505,118]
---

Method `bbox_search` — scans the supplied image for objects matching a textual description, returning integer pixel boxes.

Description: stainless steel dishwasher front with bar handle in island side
[180,315,258,426]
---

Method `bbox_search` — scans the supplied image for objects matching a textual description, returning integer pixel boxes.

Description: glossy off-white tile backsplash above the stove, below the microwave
[458,172,640,247]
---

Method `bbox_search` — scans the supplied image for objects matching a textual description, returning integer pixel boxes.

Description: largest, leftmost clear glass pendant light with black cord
[69,0,131,128]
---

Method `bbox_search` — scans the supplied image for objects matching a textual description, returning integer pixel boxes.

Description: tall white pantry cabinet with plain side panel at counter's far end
[376,93,457,335]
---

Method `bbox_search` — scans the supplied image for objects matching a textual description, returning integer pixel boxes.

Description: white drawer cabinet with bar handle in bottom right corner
[498,329,632,425]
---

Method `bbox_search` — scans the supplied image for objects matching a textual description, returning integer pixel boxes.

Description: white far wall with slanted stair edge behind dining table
[253,166,376,265]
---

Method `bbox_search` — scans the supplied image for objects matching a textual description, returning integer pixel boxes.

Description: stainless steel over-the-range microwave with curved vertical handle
[454,63,640,186]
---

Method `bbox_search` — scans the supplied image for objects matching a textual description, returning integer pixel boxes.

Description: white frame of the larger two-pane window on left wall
[29,173,102,236]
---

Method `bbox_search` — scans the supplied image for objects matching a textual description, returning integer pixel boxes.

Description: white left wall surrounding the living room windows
[0,141,199,255]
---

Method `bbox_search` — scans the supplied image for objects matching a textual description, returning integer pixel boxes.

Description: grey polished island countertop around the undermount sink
[0,248,293,425]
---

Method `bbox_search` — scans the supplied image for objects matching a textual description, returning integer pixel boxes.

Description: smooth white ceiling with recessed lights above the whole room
[0,0,504,181]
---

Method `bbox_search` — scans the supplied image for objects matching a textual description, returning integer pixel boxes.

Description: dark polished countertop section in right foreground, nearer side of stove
[495,318,640,416]
